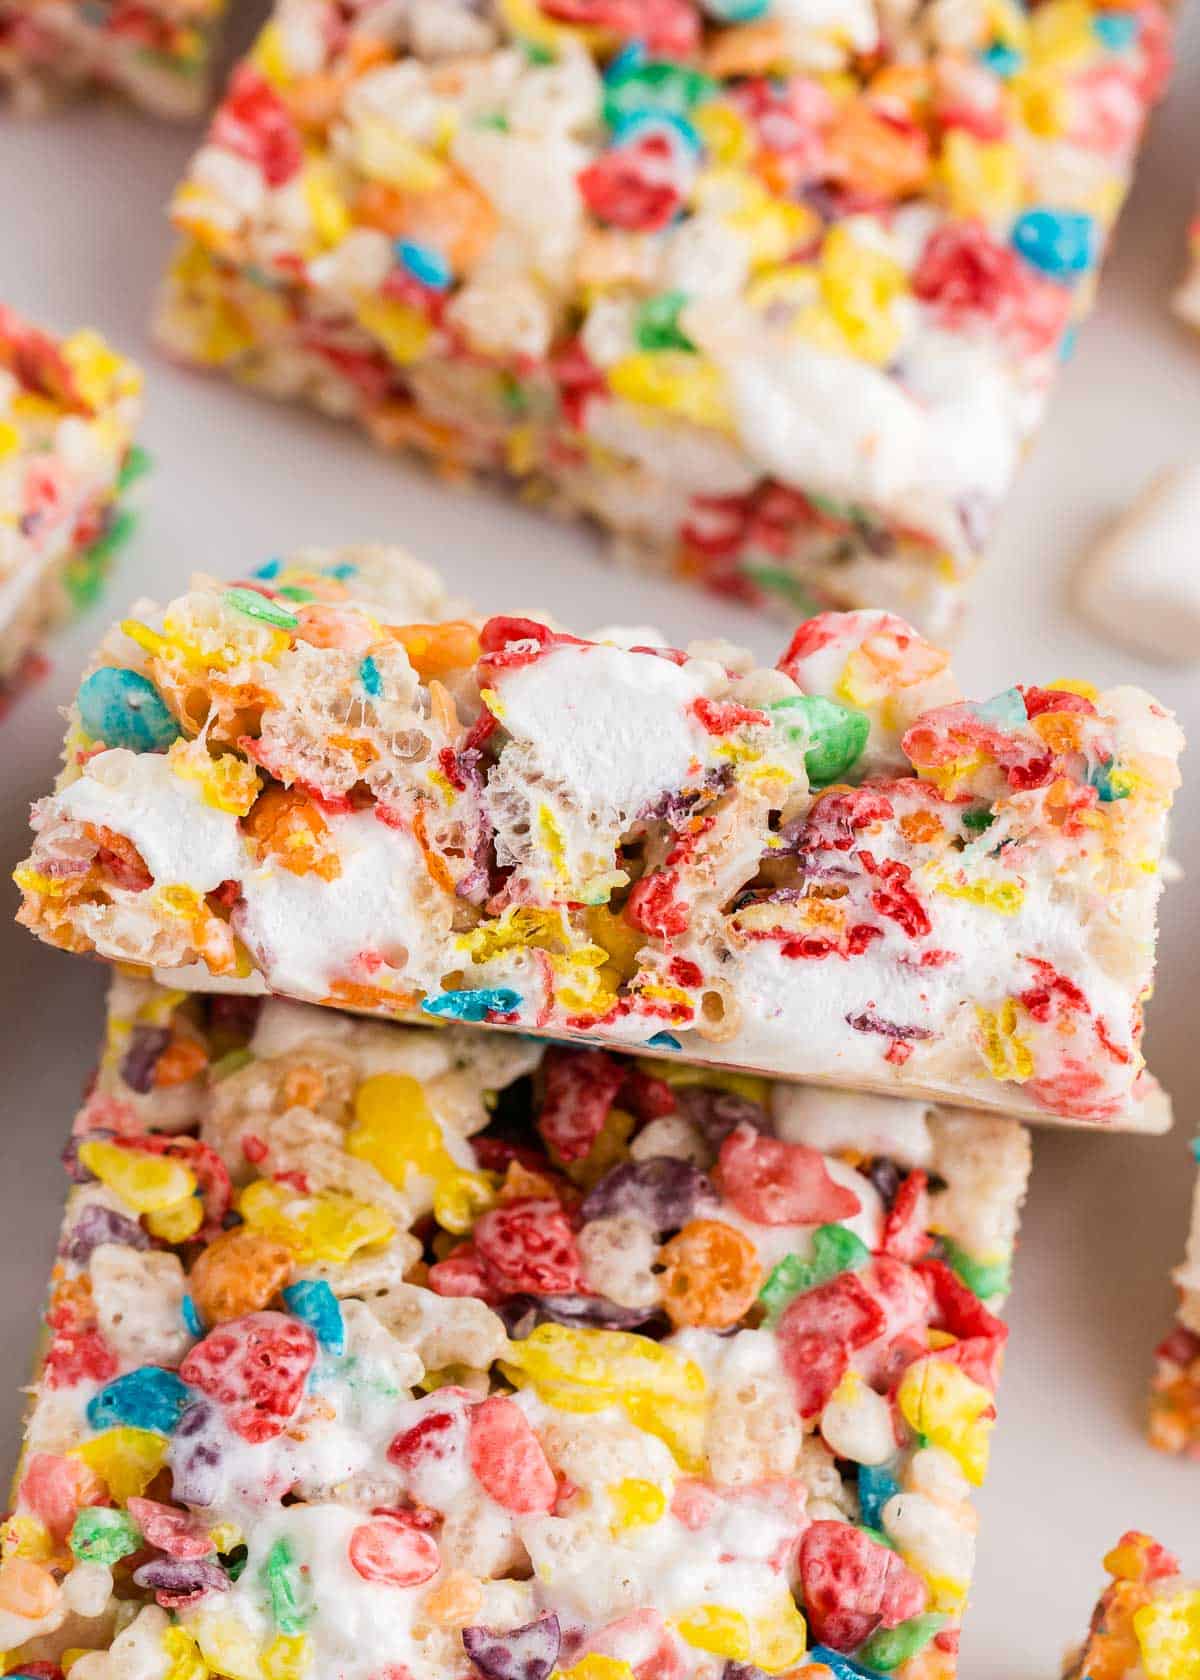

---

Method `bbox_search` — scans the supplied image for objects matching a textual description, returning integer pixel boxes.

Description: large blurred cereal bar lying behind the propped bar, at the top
[152,0,1168,635]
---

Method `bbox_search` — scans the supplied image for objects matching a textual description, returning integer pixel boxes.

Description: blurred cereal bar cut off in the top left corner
[0,0,225,118]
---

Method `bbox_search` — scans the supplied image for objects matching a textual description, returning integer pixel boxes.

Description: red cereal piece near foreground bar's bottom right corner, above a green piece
[800,1519,929,1651]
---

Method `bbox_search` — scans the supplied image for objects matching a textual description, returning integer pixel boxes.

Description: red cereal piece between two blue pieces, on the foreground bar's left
[180,1312,316,1441]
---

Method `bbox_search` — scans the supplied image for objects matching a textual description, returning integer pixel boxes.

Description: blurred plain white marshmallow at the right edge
[1074,462,1200,664]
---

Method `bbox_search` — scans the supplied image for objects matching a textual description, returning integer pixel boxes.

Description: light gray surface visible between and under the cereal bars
[0,19,1200,1680]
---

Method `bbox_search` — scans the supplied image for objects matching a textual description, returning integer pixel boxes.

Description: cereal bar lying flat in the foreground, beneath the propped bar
[0,978,1029,1680]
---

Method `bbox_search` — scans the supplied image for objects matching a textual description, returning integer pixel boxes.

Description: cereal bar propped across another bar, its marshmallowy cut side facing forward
[17,551,1180,1126]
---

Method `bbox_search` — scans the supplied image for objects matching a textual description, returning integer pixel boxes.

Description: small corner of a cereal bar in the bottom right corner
[1062,1530,1200,1680]
